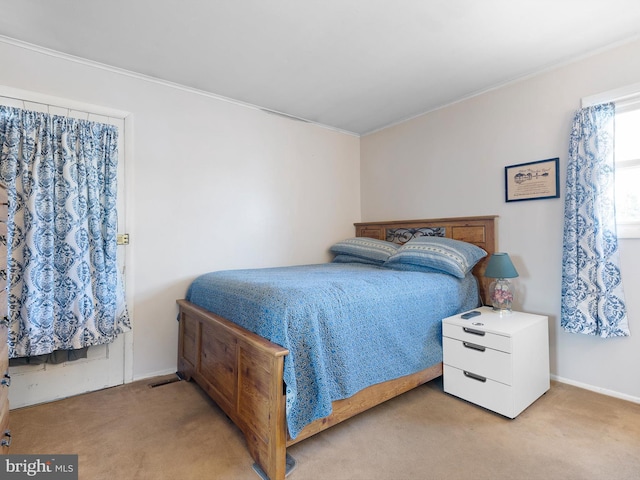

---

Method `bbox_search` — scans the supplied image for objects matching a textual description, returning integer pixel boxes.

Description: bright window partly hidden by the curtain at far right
[615,103,640,238]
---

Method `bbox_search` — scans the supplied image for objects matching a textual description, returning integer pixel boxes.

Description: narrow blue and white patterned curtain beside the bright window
[560,103,629,337]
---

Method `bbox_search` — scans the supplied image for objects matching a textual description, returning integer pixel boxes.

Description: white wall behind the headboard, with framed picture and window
[361,37,640,401]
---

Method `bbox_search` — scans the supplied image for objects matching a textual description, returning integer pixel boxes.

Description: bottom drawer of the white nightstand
[444,365,515,418]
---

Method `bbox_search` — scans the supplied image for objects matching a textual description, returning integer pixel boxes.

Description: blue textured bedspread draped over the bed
[186,263,478,438]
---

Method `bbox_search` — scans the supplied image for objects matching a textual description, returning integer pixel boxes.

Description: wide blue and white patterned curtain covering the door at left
[0,106,130,358]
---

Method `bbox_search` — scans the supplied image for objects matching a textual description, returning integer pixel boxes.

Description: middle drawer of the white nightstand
[443,337,512,385]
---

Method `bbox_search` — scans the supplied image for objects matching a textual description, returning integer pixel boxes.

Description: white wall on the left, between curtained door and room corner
[0,42,360,379]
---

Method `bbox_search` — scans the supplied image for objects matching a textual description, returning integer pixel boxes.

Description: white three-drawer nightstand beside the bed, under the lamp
[442,307,549,418]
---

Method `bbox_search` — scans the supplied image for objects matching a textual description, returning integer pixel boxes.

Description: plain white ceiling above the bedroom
[0,0,640,135]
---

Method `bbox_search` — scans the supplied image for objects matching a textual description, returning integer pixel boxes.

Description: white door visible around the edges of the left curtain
[0,88,131,408]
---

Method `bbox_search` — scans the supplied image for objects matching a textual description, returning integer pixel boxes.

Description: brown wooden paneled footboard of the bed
[178,300,289,480]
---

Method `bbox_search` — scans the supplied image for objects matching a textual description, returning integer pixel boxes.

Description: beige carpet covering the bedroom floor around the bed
[11,379,640,480]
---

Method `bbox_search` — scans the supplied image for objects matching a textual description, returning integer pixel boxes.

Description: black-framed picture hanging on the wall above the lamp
[504,158,560,202]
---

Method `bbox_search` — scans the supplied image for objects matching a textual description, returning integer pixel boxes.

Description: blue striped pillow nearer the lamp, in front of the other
[385,237,487,278]
